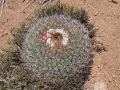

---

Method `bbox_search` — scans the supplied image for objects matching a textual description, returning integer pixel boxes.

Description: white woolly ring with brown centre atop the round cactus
[46,29,68,52]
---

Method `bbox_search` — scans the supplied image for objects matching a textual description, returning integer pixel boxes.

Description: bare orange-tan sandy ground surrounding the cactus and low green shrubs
[0,0,120,90]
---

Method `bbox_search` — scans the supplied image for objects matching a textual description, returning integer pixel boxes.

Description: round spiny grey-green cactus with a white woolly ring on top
[21,14,92,86]
